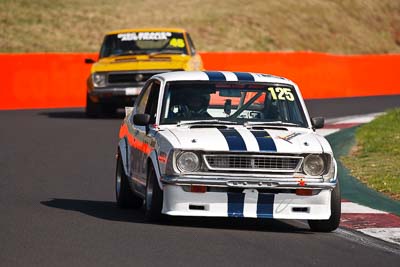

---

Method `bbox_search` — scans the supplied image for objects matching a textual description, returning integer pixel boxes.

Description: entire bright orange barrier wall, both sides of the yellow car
[0,52,400,109]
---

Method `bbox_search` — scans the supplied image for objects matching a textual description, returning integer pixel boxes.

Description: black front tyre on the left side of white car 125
[145,166,164,222]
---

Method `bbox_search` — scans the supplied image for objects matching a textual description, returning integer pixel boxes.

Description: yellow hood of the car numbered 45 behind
[92,54,191,73]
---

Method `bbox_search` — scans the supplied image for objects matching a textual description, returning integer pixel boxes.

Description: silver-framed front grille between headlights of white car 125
[204,155,303,172]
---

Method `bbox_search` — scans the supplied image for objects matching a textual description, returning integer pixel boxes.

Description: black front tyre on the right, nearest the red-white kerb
[308,180,341,232]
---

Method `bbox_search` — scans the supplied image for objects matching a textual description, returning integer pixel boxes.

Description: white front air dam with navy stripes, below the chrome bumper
[162,184,331,220]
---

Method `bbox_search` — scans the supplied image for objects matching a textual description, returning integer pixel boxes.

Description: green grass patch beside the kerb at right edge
[342,109,400,200]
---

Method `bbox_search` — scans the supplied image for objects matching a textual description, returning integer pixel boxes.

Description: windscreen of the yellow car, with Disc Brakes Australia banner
[100,32,188,58]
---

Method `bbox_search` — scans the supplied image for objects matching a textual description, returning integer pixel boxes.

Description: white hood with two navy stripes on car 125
[161,126,331,154]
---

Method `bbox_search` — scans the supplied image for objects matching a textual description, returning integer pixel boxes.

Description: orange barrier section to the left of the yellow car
[0,54,95,109]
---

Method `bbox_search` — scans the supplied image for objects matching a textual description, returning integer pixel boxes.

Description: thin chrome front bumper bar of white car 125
[161,176,336,190]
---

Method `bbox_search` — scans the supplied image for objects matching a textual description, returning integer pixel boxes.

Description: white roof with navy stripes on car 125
[155,71,295,85]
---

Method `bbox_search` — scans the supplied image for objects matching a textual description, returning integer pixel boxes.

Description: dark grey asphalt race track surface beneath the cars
[0,96,400,266]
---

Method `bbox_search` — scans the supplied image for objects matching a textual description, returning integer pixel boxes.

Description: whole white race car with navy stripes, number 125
[116,71,340,231]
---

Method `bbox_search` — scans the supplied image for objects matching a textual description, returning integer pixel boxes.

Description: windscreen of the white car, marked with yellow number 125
[160,81,307,127]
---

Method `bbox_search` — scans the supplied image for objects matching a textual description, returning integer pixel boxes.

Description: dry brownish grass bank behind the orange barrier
[0,0,400,54]
